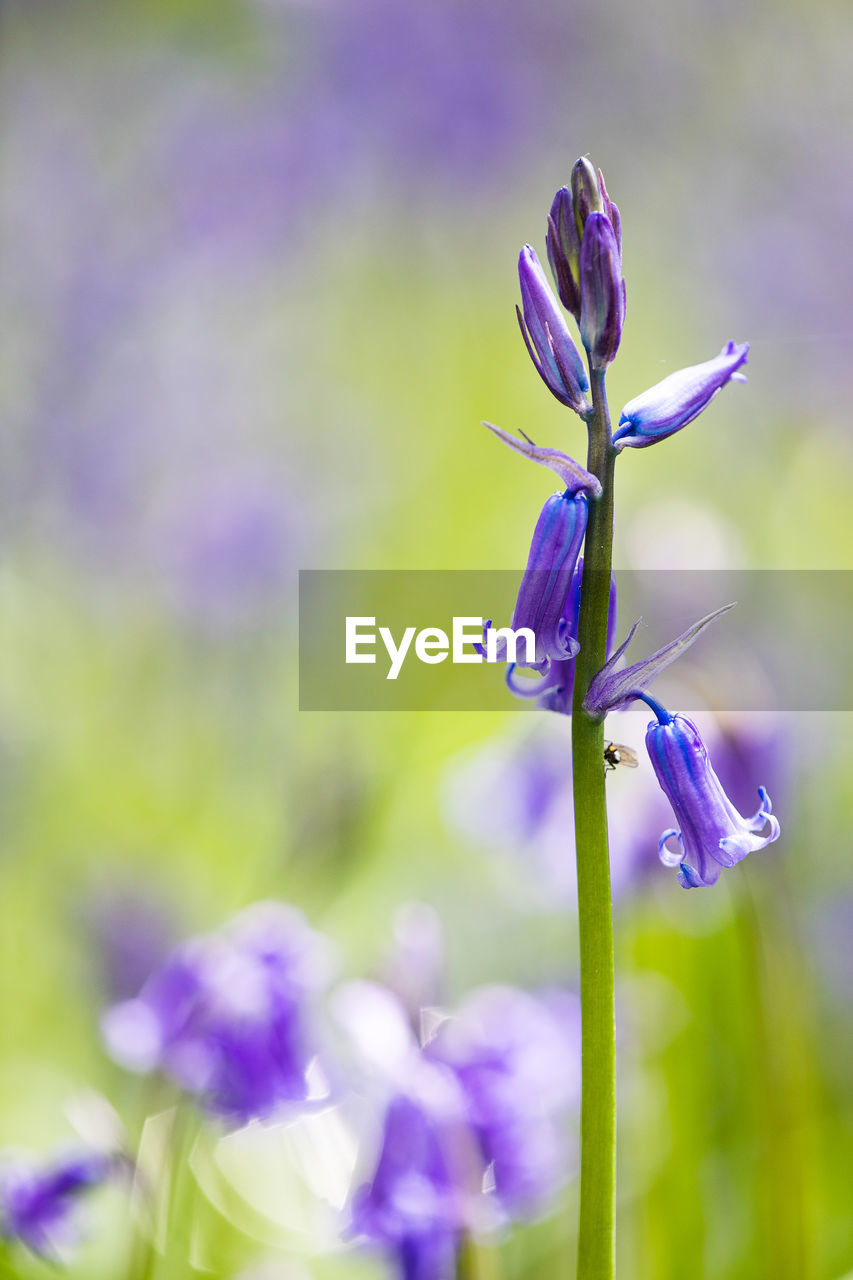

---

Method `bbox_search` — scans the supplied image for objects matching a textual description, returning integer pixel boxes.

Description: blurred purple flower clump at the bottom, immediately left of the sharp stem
[343,984,579,1280]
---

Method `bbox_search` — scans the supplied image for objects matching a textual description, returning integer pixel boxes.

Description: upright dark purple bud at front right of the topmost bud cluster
[580,212,625,369]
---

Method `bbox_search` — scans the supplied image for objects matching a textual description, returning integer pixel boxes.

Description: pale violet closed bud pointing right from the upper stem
[613,342,749,449]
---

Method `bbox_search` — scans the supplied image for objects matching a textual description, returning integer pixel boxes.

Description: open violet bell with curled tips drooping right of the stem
[646,703,780,888]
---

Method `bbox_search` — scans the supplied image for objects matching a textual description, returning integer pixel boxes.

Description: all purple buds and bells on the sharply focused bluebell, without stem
[485,157,779,887]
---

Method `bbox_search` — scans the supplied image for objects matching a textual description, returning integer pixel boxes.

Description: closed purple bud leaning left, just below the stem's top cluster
[515,244,589,416]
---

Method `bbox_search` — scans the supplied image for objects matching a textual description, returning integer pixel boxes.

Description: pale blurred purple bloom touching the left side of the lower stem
[425,987,580,1217]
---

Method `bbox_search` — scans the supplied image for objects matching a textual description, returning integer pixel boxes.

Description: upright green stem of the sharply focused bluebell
[571,371,616,1280]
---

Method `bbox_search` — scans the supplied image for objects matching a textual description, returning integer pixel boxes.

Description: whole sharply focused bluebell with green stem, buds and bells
[479,157,775,1280]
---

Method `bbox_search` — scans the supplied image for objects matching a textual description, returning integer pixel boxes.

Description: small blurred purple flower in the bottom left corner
[0,1153,110,1262]
